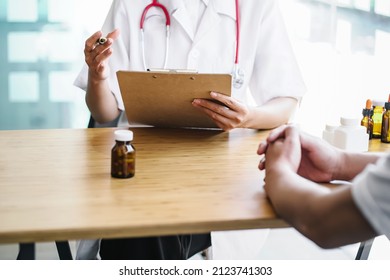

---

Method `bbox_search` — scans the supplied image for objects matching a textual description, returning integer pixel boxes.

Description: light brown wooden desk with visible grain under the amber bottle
[0,128,287,243]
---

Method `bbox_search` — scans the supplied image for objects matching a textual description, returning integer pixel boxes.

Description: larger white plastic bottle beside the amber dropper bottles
[333,117,369,152]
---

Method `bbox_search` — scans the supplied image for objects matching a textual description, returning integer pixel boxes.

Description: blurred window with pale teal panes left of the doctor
[0,0,111,129]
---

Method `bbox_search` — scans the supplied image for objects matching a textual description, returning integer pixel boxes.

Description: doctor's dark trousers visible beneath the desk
[100,233,211,260]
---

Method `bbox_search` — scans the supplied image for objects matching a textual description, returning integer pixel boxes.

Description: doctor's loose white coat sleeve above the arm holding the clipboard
[248,1,306,105]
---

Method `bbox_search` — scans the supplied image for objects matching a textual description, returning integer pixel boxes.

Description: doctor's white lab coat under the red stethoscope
[75,0,305,259]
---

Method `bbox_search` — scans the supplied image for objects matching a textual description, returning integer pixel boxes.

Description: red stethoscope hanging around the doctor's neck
[140,0,244,89]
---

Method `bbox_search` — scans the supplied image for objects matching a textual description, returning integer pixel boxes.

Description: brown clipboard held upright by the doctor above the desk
[117,71,232,128]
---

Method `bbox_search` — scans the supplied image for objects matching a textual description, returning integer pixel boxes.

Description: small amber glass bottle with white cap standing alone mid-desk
[111,130,135,178]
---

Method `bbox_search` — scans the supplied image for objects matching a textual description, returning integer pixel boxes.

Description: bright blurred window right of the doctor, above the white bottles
[280,0,390,136]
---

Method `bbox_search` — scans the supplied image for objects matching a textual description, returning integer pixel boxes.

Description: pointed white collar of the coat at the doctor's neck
[160,0,236,43]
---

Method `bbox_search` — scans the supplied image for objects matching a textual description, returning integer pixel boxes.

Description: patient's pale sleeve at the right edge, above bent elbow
[352,154,390,239]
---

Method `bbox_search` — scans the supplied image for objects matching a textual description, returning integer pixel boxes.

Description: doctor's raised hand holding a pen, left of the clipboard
[84,29,119,81]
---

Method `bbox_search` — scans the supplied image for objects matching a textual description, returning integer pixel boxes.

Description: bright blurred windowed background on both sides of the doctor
[0,0,390,134]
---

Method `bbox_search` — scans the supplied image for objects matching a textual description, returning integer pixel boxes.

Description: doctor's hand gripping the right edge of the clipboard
[192,92,250,131]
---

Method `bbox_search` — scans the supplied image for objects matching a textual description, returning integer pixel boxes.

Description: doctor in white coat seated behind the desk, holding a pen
[75,0,305,259]
